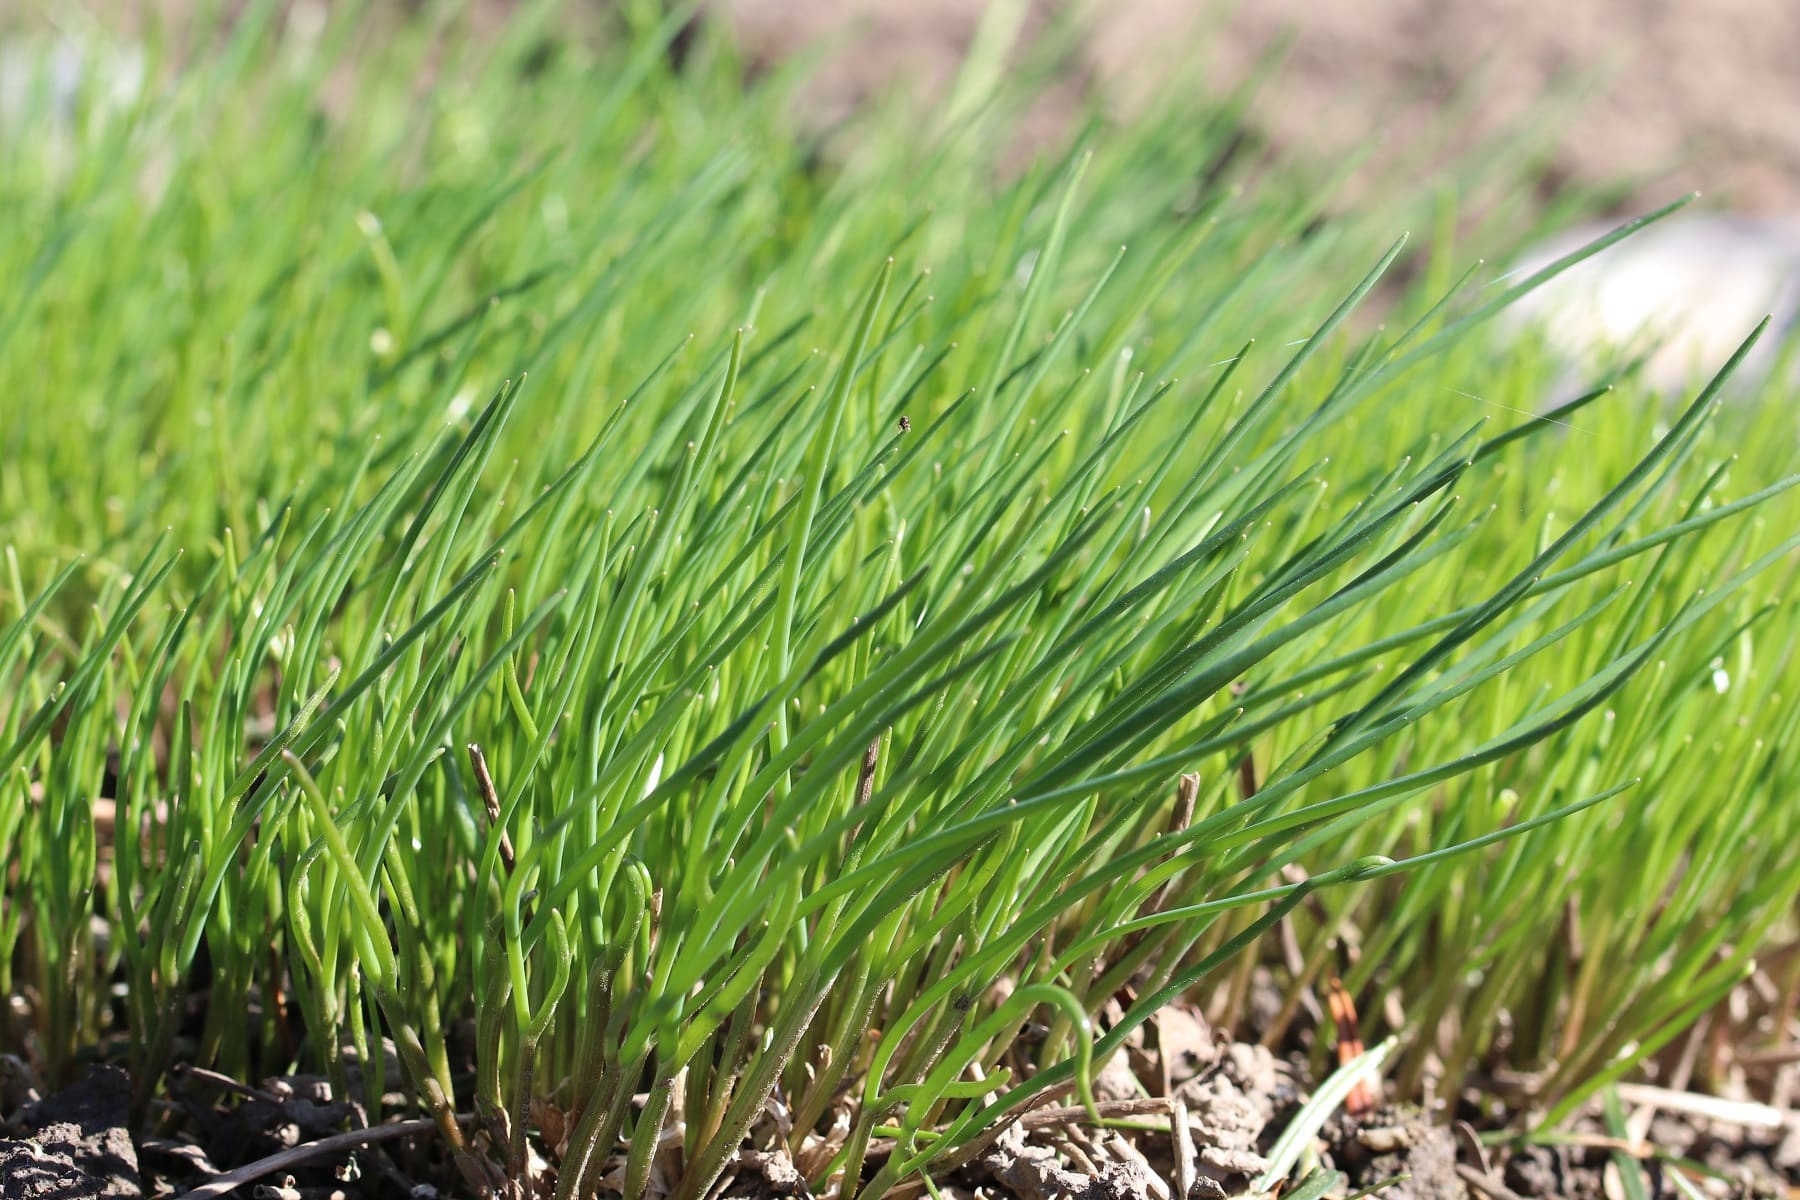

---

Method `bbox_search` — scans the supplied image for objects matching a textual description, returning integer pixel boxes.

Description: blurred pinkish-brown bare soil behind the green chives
[716,0,1800,212]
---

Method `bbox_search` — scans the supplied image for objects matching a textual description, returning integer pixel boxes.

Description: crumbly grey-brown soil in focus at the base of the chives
[0,1007,1800,1200]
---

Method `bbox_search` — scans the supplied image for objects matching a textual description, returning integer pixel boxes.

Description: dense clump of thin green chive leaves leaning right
[0,4,1795,1200]
